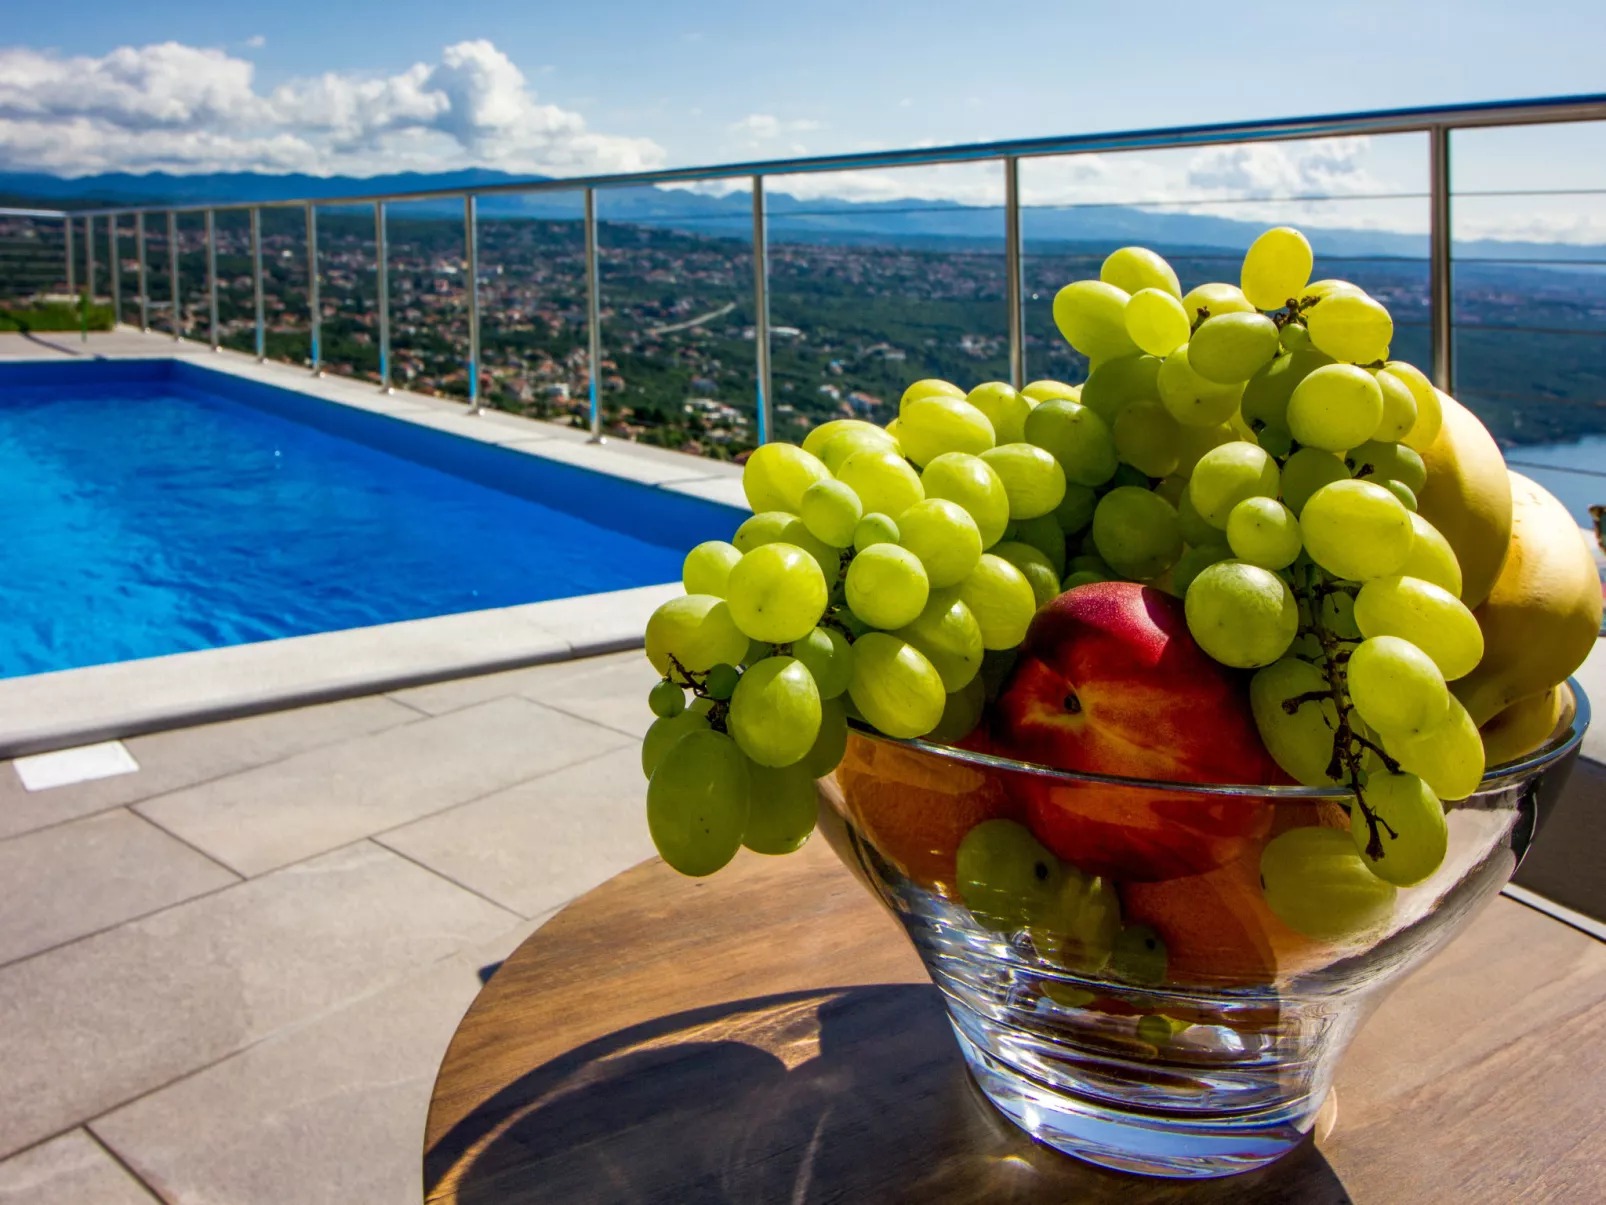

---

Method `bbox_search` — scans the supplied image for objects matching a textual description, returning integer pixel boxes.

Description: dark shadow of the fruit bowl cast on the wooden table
[424,985,1349,1205]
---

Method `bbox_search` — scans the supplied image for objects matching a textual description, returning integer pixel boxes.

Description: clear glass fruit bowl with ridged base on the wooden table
[819,683,1590,1178]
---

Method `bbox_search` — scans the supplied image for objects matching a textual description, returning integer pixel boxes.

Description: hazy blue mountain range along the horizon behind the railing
[0,167,1606,263]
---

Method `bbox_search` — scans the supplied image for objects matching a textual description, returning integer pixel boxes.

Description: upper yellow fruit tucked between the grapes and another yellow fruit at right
[1416,390,1511,609]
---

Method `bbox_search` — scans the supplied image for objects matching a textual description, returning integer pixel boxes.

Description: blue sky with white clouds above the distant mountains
[0,0,1606,241]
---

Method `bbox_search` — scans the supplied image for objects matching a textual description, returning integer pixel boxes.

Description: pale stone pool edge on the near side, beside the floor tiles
[0,582,681,758]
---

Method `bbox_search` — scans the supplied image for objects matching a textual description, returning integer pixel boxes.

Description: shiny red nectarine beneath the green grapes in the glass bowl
[993,582,1288,882]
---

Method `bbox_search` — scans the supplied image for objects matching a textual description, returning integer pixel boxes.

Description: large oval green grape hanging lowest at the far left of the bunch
[647,729,753,877]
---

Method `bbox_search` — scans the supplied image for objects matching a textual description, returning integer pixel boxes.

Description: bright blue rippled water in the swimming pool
[0,362,739,676]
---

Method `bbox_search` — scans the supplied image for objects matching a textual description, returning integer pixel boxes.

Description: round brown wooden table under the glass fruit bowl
[424,839,1606,1205]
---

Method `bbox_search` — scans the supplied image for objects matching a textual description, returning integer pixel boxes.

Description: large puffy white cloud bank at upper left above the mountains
[0,40,663,175]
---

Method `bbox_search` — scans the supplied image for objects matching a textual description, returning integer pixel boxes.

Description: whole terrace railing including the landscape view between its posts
[0,96,1606,522]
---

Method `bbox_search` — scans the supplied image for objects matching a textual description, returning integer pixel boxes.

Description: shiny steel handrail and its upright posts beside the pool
[9,93,1606,440]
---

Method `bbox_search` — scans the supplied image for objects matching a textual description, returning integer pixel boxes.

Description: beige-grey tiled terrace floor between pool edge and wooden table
[0,652,655,1205]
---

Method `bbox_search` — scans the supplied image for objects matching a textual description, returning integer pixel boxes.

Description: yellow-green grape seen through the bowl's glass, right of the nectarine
[1261,827,1399,942]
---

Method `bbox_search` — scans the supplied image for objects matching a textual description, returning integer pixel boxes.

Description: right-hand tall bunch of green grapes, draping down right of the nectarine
[1047,228,1484,938]
